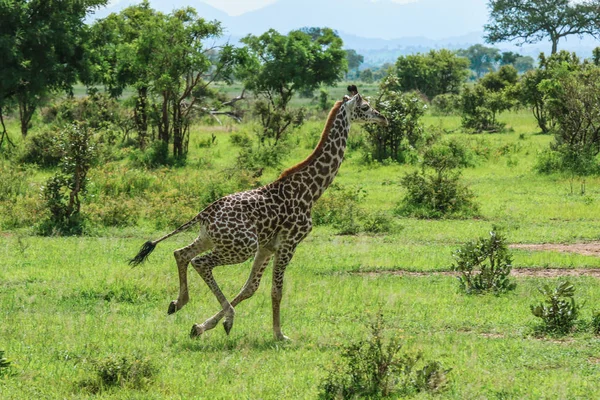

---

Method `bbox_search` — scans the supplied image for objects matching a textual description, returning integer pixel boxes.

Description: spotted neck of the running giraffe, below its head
[289,104,350,207]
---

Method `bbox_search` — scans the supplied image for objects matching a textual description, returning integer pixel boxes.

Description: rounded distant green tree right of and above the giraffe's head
[395,49,469,99]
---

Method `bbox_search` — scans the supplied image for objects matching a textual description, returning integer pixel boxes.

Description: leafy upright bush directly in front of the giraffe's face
[364,76,427,162]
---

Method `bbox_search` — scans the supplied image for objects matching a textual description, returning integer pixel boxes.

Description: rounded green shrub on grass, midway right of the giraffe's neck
[396,141,478,219]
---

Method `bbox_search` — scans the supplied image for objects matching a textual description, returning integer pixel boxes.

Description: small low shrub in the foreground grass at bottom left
[81,354,158,393]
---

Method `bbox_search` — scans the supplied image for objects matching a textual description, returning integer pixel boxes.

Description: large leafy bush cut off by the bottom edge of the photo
[319,314,450,399]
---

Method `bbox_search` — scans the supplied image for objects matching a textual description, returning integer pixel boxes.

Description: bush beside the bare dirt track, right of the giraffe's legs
[453,229,516,294]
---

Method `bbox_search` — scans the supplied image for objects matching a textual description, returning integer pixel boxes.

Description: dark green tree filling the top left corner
[0,0,106,137]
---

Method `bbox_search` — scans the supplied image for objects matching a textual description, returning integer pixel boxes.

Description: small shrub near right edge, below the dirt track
[530,281,582,334]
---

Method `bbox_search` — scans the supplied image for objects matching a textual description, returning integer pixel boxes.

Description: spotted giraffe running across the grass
[130,85,388,340]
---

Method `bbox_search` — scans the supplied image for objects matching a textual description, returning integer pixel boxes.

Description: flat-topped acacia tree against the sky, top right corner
[484,0,600,54]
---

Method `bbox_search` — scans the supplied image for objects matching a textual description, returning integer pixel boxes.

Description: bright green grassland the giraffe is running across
[0,89,600,399]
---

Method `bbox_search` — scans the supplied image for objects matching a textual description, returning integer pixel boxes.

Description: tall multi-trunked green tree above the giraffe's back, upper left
[88,1,237,158]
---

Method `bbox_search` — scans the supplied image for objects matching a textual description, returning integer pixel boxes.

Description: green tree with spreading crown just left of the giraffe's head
[238,28,347,144]
